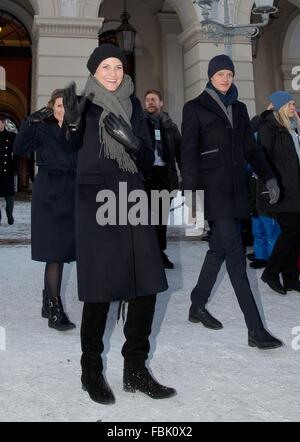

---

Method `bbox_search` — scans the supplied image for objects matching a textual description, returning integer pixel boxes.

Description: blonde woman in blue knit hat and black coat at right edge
[258,91,300,295]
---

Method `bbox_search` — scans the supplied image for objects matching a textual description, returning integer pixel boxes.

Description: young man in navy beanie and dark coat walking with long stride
[181,55,282,349]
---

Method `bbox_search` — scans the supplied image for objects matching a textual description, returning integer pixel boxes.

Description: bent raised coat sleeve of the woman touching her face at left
[13,119,46,156]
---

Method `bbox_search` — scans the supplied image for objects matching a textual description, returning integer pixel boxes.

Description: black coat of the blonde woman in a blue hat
[257,111,300,213]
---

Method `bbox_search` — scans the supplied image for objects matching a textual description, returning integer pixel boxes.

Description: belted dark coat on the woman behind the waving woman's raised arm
[14,120,77,263]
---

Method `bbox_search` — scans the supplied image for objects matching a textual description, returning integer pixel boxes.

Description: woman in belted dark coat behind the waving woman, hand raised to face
[14,90,77,331]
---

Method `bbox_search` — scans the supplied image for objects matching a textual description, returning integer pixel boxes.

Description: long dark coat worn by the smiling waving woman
[71,98,168,303]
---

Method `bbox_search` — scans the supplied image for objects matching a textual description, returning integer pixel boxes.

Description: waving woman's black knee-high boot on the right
[122,295,176,399]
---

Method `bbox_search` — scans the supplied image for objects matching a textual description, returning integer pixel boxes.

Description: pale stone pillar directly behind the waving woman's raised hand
[32,16,103,110]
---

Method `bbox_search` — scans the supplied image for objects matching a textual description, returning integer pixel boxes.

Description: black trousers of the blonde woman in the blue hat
[264,213,300,284]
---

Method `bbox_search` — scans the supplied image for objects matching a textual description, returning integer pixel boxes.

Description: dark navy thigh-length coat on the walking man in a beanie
[181,91,274,220]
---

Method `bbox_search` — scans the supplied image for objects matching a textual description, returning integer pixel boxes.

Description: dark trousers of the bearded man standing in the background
[147,166,171,250]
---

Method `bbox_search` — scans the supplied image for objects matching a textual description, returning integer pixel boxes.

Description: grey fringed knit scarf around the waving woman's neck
[85,75,137,173]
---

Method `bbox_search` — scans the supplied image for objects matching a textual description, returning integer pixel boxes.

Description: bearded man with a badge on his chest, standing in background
[144,89,181,269]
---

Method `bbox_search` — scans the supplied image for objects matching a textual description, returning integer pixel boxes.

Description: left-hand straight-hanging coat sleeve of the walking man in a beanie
[180,102,202,190]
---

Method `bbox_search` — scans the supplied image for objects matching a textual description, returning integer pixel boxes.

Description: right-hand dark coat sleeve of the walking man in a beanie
[244,106,275,183]
